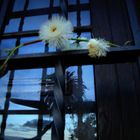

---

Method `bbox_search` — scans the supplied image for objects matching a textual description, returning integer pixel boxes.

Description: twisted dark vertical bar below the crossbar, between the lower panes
[52,60,65,140]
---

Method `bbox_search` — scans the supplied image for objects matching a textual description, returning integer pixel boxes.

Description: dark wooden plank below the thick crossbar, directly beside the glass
[95,65,122,140]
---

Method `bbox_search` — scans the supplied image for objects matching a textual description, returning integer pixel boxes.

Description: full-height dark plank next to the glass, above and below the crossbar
[93,0,122,140]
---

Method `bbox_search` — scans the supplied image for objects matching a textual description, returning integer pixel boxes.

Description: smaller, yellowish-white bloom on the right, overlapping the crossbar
[87,39,110,57]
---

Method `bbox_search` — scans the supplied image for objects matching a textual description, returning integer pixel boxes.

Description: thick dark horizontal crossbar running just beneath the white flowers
[0,46,140,70]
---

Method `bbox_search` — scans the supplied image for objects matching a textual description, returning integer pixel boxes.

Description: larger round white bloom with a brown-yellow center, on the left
[39,16,73,49]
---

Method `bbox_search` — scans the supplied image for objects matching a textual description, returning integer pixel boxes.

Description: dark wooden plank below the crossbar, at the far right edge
[117,63,140,140]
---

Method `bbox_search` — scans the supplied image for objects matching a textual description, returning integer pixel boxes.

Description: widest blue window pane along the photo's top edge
[28,0,50,9]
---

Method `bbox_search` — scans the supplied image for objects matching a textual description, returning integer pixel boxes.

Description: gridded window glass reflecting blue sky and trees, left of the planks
[0,0,97,140]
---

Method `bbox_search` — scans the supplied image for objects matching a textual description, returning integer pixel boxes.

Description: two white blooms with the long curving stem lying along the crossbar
[0,16,118,75]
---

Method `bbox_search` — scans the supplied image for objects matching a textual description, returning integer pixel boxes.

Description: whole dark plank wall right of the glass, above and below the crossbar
[93,0,140,140]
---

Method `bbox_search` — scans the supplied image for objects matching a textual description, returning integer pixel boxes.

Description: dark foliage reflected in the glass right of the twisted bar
[66,66,97,140]
